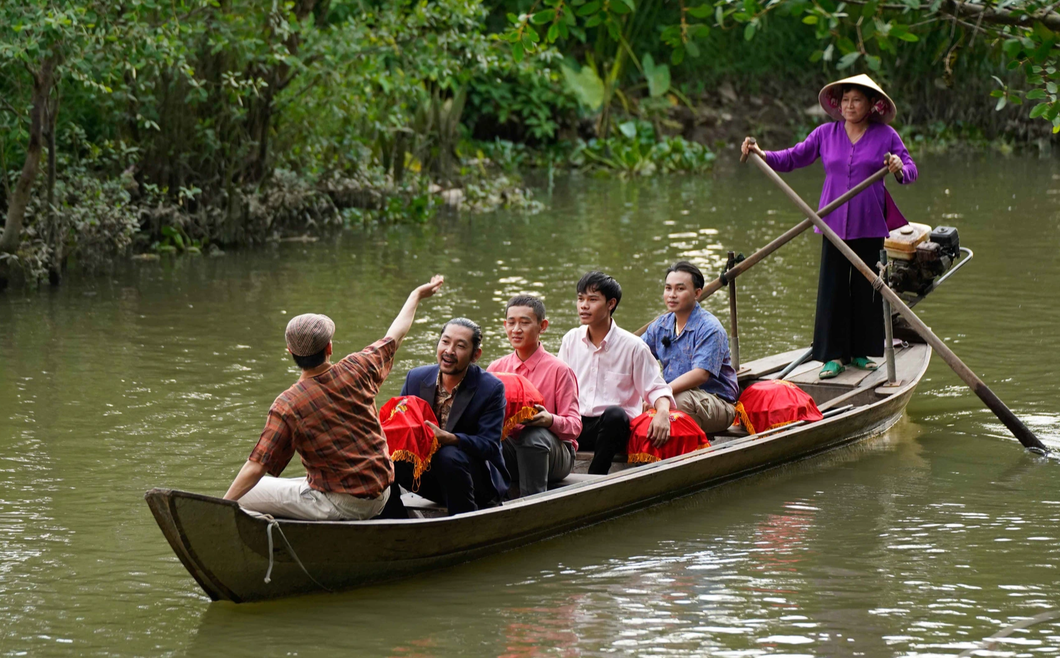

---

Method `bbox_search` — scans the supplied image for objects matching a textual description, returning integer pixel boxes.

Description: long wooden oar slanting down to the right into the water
[750,147,1049,455]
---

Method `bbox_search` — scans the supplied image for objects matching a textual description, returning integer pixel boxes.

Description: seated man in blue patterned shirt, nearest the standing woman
[641,261,740,434]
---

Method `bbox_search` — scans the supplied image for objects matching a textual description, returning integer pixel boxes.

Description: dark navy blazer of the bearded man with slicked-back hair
[401,364,512,500]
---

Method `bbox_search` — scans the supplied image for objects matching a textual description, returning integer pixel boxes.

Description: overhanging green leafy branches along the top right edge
[499,0,1060,128]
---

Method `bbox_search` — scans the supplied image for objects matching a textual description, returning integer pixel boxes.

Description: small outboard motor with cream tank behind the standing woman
[884,224,960,296]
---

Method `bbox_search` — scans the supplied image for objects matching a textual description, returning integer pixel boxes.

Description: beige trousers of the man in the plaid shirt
[240,476,390,521]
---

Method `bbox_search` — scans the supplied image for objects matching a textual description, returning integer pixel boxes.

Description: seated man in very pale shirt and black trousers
[560,272,675,475]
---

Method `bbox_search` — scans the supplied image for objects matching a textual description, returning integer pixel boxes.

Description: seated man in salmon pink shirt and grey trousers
[487,295,582,496]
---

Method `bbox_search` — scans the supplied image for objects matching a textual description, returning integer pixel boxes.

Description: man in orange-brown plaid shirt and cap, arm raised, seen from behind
[225,275,442,520]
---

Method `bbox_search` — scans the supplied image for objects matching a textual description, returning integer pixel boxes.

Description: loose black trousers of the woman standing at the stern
[813,237,885,362]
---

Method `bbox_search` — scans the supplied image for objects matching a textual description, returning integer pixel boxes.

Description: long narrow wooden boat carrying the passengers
[146,344,932,603]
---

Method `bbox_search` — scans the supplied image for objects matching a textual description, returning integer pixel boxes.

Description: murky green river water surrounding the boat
[0,157,1060,657]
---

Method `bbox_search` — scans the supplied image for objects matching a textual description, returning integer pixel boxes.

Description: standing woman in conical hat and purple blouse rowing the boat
[742,75,917,379]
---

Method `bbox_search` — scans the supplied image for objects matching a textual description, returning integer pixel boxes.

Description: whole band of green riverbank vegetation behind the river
[0,0,1060,285]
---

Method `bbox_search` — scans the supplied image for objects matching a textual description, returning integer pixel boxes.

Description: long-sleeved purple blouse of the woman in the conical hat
[765,121,917,239]
